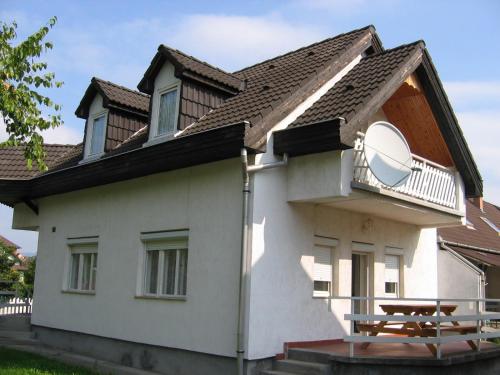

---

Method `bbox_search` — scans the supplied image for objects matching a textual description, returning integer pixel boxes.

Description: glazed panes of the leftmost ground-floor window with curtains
[68,244,97,292]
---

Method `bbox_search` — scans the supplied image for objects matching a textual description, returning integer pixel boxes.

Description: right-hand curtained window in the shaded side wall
[142,231,188,297]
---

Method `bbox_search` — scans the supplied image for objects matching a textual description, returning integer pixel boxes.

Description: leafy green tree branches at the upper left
[0,17,63,170]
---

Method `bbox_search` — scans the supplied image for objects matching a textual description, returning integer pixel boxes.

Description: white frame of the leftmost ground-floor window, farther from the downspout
[62,237,99,295]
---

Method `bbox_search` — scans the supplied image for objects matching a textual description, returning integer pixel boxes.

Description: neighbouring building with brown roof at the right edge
[438,198,500,310]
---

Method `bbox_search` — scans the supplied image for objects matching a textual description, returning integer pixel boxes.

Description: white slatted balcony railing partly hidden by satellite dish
[353,133,457,212]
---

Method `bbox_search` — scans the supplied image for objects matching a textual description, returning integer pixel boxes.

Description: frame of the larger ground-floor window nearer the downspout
[136,230,189,300]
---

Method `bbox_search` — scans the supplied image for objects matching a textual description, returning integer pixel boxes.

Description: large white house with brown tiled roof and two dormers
[0,27,482,374]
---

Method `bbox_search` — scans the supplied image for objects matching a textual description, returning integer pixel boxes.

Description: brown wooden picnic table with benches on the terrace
[357,304,477,355]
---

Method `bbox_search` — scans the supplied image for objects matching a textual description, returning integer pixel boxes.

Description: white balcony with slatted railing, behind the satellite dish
[287,134,465,227]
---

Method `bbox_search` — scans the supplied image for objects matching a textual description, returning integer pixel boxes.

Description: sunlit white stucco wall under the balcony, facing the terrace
[248,153,437,359]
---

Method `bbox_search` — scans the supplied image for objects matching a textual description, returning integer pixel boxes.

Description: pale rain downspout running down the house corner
[236,148,288,375]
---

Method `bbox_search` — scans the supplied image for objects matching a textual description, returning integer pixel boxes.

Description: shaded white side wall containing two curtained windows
[32,159,241,356]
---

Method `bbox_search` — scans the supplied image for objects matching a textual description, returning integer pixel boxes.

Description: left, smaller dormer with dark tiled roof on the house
[75,77,149,162]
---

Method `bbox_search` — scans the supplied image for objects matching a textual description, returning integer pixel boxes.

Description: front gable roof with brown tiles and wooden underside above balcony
[275,41,482,197]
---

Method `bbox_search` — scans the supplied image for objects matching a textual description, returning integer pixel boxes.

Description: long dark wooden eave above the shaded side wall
[0,122,249,207]
